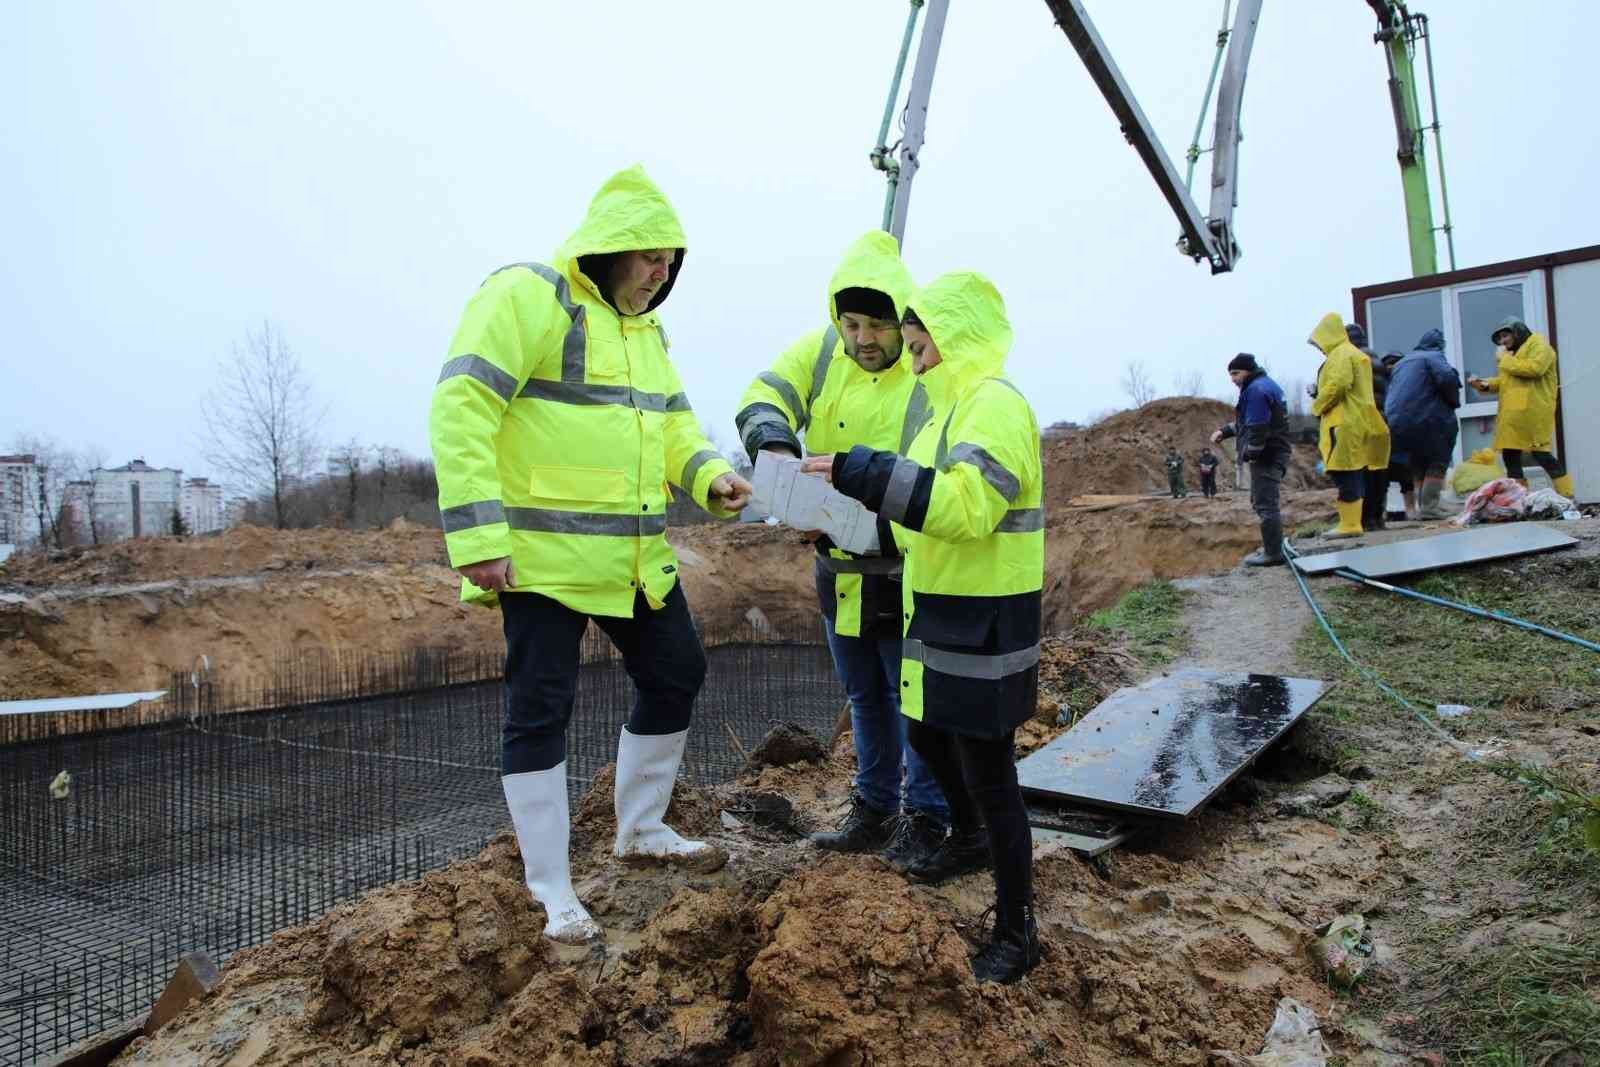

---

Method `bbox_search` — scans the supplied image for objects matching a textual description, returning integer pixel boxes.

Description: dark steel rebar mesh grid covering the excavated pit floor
[0,622,843,1065]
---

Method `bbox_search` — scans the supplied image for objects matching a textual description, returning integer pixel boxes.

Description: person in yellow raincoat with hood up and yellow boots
[1309,312,1389,537]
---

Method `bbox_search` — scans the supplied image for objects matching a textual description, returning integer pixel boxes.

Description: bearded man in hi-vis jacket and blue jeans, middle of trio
[734,230,949,867]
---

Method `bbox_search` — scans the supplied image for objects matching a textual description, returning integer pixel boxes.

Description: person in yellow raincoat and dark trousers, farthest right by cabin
[1467,318,1573,499]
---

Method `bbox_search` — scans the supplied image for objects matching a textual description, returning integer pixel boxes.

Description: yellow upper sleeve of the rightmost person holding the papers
[922,382,1038,544]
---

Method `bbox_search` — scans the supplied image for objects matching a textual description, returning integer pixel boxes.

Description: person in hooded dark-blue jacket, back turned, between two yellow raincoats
[1384,330,1461,518]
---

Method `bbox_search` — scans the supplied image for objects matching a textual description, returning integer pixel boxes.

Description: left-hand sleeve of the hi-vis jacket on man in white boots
[427,269,571,566]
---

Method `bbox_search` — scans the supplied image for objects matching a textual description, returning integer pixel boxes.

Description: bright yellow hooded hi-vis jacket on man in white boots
[429,166,731,617]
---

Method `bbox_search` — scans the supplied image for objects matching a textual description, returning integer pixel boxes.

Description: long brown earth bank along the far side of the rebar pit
[0,398,1331,699]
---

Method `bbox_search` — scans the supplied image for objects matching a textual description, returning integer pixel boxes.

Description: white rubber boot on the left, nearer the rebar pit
[501,760,600,945]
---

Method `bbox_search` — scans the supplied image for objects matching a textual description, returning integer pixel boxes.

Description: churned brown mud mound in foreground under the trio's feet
[106,742,1384,1067]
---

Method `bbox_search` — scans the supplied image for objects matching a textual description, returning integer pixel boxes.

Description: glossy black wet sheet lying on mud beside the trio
[1016,669,1326,821]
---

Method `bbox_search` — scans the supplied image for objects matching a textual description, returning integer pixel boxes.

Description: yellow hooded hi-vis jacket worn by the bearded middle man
[734,230,928,637]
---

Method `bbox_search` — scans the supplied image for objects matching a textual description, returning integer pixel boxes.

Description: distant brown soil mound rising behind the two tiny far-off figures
[1045,397,1326,509]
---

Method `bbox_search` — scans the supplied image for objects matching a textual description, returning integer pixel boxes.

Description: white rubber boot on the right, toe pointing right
[616,726,728,872]
